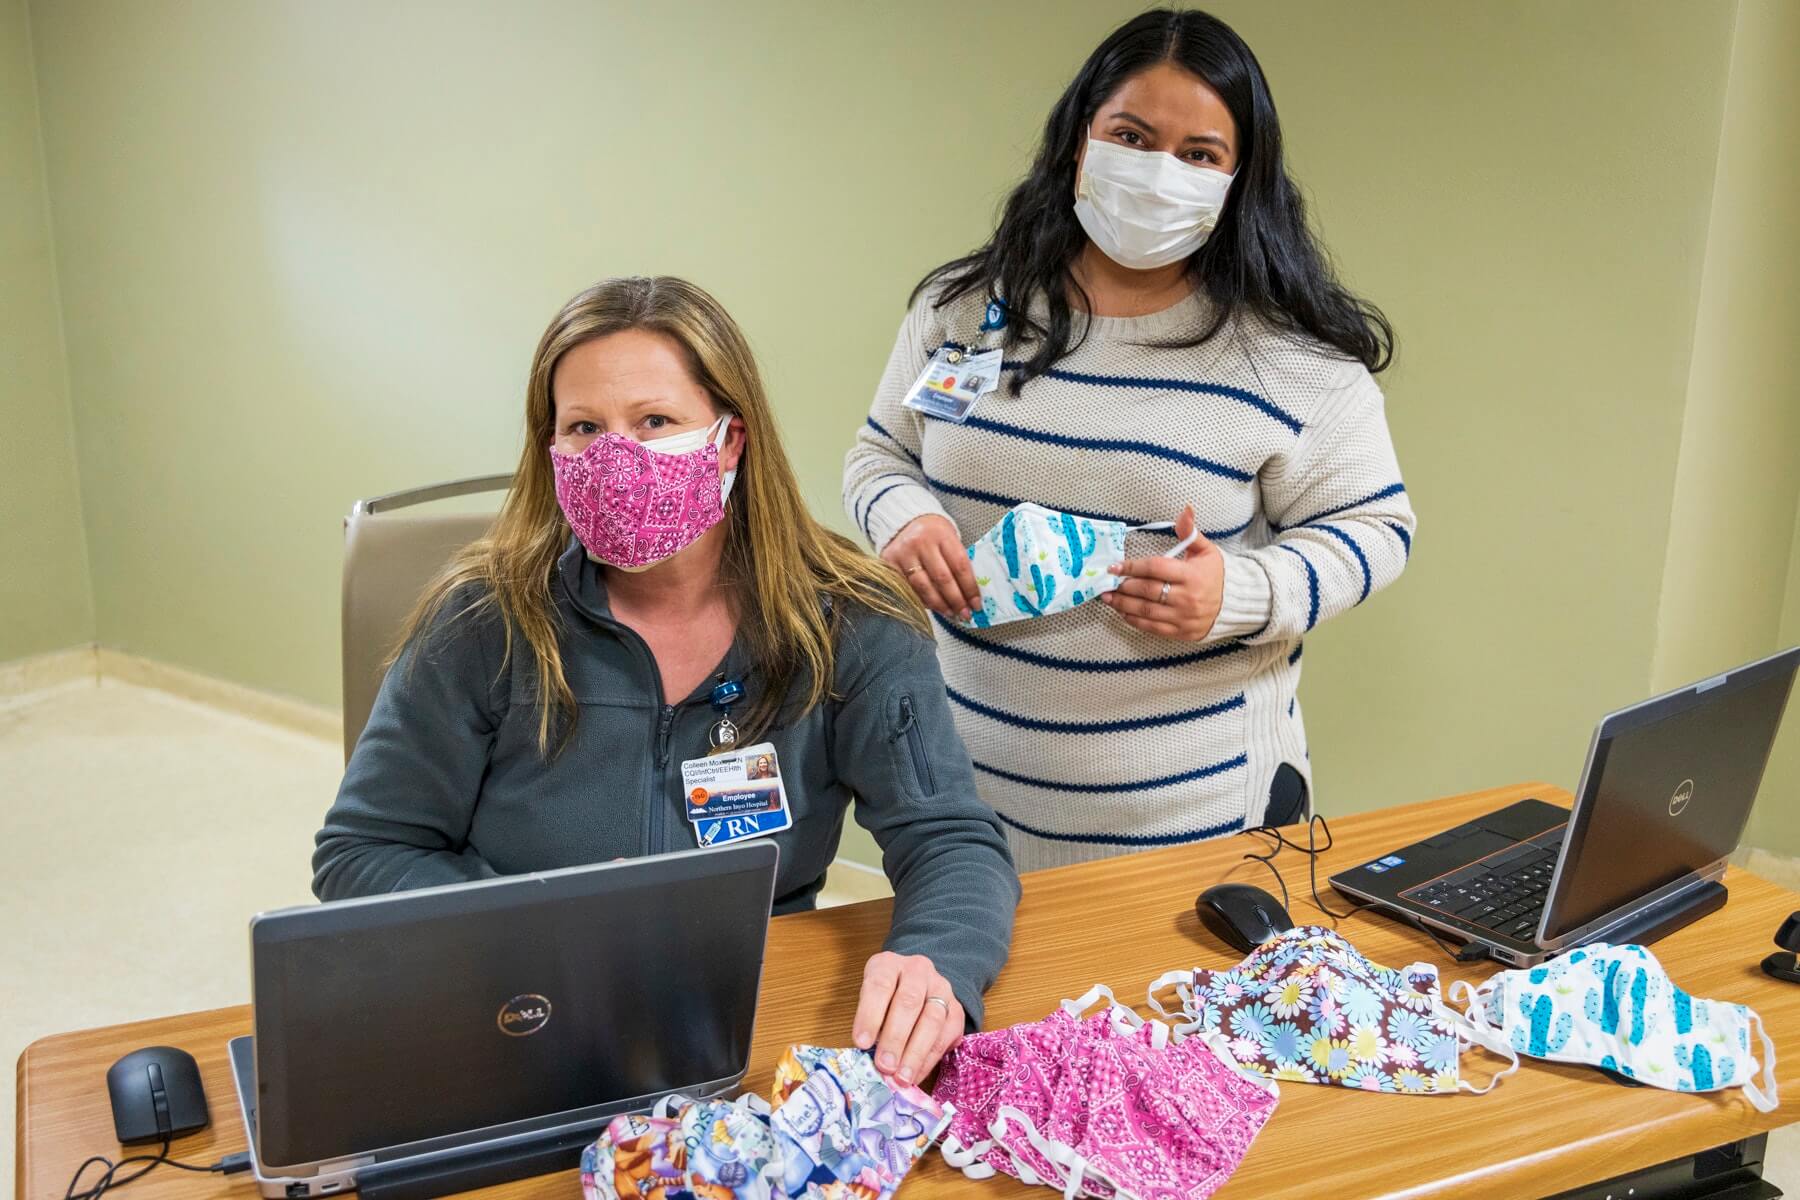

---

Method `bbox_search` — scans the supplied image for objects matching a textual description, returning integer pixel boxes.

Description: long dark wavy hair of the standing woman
[913,9,1393,396]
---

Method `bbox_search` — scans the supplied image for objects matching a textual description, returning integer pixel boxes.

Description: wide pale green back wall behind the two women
[34,0,1793,874]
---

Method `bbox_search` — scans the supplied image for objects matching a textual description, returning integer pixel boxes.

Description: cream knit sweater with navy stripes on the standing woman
[844,297,1415,871]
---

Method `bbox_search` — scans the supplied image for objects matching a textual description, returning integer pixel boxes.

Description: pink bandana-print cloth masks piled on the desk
[932,988,1278,1200]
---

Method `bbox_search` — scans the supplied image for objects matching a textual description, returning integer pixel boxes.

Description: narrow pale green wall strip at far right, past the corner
[1651,0,1800,698]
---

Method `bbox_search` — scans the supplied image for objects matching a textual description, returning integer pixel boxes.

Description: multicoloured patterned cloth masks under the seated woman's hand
[581,1045,949,1200]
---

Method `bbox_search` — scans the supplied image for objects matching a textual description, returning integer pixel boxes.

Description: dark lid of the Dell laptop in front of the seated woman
[252,842,776,1166]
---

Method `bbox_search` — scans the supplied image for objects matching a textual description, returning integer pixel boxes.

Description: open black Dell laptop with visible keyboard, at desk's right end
[1332,646,1800,966]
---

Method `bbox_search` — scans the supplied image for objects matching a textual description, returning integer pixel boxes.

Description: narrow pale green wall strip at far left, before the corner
[0,0,94,662]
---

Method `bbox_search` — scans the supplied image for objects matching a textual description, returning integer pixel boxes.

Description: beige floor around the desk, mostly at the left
[0,680,1800,1196]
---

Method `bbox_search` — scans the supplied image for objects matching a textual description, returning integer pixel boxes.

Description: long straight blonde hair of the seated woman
[394,275,931,756]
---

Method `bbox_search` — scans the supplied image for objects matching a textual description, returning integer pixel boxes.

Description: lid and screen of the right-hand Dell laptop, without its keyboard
[1544,649,1800,939]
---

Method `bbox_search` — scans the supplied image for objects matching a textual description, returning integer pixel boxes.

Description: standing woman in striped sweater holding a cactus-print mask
[844,11,1415,871]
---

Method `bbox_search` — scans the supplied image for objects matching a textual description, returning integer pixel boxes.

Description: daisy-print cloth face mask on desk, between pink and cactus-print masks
[1148,925,1519,1094]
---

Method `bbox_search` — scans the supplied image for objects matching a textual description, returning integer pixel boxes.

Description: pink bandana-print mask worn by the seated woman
[551,416,734,570]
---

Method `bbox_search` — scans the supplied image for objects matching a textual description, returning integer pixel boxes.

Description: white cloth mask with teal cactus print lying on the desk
[1451,943,1777,1112]
